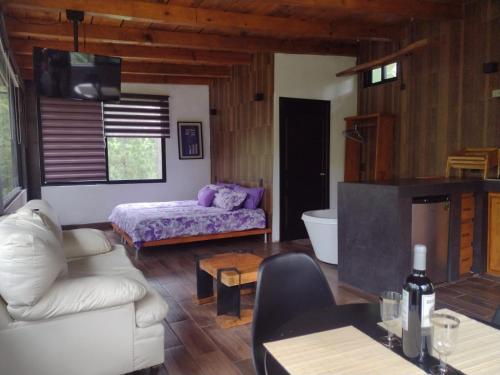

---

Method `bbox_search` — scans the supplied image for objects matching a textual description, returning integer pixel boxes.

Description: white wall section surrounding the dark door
[273,53,357,241]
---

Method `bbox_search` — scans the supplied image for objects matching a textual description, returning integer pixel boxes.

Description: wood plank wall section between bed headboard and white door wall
[210,53,274,226]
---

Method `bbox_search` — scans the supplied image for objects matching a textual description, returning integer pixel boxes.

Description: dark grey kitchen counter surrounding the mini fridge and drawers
[338,178,500,293]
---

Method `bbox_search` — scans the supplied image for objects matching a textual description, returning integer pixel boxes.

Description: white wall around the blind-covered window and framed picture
[42,84,210,225]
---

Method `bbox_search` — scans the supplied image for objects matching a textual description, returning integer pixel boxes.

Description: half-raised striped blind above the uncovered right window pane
[103,94,170,138]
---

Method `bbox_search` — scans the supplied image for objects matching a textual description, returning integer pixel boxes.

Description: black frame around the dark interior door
[278,96,331,241]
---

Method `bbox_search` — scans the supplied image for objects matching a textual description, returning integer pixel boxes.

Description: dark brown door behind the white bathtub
[280,98,330,241]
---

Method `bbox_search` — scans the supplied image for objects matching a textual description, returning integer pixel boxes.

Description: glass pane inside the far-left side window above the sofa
[0,78,18,201]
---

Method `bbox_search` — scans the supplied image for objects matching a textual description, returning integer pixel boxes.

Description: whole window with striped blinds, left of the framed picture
[40,94,170,184]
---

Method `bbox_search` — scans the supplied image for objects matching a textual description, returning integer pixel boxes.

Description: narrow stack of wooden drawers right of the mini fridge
[460,193,475,275]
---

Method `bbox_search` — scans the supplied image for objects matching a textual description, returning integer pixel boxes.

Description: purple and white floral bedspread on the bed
[109,200,266,248]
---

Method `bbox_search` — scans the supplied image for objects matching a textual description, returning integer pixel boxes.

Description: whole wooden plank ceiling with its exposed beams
[2,0,463,84]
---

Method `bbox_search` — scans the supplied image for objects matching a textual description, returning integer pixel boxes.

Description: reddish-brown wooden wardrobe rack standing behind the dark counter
[344,113,395,182]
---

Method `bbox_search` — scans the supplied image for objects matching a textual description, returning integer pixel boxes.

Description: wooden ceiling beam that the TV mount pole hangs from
[4,0,400,40]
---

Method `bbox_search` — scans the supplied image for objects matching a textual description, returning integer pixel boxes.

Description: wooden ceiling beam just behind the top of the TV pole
[5,18,357,56]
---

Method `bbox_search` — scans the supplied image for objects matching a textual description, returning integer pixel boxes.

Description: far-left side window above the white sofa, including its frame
[0,48,20,206]
